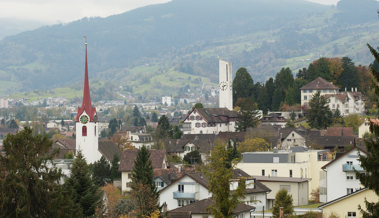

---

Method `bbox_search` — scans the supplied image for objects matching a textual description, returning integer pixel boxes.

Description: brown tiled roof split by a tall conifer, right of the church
[118,150,166,172]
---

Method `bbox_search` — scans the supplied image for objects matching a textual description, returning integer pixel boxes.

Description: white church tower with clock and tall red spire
[76,42,101,164]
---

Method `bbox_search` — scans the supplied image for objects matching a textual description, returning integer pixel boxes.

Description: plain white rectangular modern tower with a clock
[219,60,233,110]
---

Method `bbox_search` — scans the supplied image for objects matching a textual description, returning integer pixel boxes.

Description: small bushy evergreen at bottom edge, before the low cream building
[272,188,293,217]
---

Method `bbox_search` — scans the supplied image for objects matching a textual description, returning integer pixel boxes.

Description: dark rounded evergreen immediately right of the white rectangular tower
[233,67,254,105]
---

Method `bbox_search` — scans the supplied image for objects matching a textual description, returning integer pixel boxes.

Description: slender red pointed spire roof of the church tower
[76,43,96,122]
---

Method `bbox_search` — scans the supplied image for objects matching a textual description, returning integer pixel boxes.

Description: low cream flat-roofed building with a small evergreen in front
[255,176,311,208]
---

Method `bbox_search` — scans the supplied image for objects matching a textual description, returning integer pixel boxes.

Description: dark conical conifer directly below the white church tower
[64,151,102,216]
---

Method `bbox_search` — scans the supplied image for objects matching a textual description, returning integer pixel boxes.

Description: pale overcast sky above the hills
[0,0,338,24]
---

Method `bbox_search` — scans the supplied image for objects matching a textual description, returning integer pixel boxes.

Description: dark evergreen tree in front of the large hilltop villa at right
[307,92,332,129]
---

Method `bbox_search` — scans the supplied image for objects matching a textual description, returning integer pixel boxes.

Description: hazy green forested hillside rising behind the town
[0,0,379,98]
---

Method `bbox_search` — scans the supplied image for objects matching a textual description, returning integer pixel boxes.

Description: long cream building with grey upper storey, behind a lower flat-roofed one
[236,147,331,199]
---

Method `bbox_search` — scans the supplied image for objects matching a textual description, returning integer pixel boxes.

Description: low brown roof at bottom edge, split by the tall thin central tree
[168,198,255,214]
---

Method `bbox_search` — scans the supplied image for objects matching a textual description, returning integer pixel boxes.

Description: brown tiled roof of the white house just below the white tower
[184,108,238,123]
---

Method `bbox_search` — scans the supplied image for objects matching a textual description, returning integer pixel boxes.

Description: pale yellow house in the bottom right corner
[318,189,379,218]
